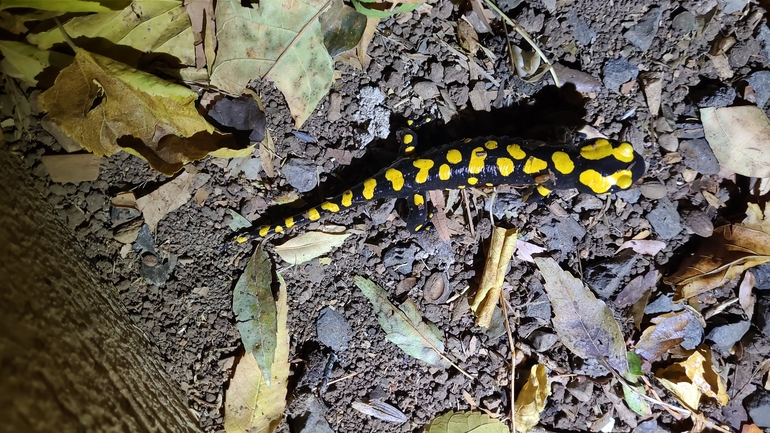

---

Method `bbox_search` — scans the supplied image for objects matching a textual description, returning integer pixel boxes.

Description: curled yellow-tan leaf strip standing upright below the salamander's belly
[471,227,517,328]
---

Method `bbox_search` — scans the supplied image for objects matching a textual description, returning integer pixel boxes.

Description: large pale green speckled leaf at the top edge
[211,0,334,129]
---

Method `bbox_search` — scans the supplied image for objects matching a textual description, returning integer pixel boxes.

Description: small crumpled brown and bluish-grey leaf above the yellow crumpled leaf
[636,310,703,365]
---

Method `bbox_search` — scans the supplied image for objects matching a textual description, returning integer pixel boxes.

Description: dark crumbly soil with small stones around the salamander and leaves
[9,0,770,433]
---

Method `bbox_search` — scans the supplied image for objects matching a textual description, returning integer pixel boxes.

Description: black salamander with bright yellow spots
[258,131,645,237]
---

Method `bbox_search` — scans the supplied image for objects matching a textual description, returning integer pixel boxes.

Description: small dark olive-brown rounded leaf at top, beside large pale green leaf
[321,0,366,57]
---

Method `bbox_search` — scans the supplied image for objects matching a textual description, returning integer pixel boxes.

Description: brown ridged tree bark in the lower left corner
[0,149,200,432]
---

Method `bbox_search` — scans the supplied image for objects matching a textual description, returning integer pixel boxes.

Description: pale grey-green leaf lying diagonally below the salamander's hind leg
[355,276,448,367]
